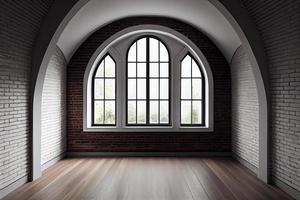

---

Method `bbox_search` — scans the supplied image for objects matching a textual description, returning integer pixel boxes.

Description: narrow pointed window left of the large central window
[92,54,116,126]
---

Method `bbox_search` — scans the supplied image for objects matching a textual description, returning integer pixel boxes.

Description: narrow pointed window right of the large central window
[180,54,205,126]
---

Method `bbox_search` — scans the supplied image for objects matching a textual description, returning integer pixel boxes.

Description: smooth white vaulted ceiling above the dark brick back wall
[57,0,241,61]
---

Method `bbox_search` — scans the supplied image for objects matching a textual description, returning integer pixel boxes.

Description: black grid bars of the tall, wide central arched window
[126,36,171,126]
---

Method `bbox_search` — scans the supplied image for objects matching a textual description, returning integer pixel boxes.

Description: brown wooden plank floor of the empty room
[5,158,291,200]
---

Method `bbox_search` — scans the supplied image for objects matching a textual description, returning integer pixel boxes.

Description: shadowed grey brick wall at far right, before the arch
[242,0,300,191]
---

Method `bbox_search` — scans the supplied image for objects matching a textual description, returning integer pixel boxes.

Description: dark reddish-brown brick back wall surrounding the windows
[67,17,231,152]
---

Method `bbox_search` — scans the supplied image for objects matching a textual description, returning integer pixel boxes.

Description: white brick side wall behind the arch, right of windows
[230,46,259,168]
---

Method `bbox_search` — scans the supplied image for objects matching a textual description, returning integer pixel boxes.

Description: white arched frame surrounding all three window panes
[83,25,214,132]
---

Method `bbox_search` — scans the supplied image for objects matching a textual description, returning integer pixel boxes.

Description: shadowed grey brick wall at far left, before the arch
[0,0,52,190]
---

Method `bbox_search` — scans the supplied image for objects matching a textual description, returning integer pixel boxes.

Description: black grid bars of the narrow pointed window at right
[180,53,205,126]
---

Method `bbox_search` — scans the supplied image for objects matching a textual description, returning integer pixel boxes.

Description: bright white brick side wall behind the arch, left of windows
[41,47,67,165]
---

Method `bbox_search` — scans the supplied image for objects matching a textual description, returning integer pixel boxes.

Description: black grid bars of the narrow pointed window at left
[92,54,117,126]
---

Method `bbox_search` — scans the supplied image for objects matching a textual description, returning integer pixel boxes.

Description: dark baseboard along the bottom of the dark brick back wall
[66,152,231,157]
